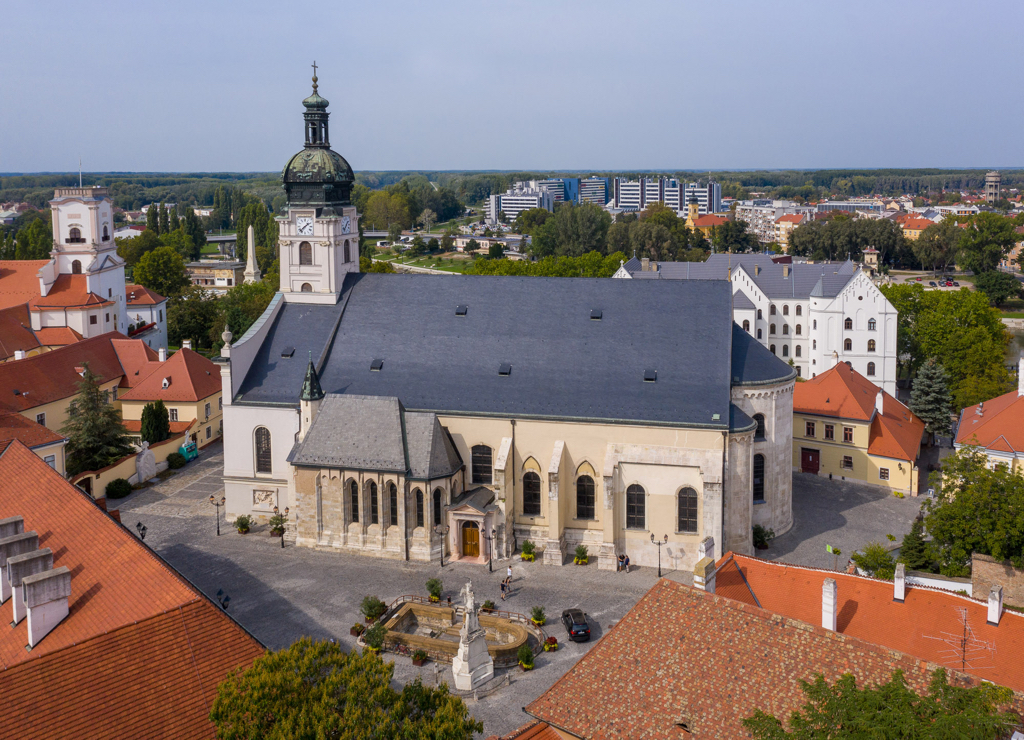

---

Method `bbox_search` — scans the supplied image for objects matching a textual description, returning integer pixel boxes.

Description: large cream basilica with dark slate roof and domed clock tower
[221,77,796,569]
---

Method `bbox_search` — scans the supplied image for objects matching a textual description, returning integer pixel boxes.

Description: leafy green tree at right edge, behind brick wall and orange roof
[925,440,1024,576]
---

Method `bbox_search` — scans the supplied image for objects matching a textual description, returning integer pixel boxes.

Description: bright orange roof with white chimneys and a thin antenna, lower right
[715,553,1024,692]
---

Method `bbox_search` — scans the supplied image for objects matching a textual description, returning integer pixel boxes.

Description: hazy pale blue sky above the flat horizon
[0,0,1024,172]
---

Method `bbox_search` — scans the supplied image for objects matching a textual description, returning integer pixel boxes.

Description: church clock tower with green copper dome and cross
[278,62,359,304]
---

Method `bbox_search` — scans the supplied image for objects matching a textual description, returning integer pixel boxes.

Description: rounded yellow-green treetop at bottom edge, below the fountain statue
[210,638,483,740]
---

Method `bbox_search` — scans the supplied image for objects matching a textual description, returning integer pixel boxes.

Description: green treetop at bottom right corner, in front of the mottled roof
[743,668,1018,740]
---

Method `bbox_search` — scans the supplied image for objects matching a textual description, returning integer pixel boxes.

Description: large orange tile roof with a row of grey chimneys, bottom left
[0,442,264,739]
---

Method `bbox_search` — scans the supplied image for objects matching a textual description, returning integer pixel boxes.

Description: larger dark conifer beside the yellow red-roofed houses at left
[60,362,135,475]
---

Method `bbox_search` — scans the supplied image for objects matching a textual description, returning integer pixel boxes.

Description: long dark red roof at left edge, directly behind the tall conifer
[0,332,125,411]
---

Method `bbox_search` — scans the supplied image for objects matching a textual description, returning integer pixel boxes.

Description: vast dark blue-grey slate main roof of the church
[237,274,765,429]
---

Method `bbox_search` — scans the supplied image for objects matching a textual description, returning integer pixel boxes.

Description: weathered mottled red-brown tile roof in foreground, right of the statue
[526,579,1019,740]
